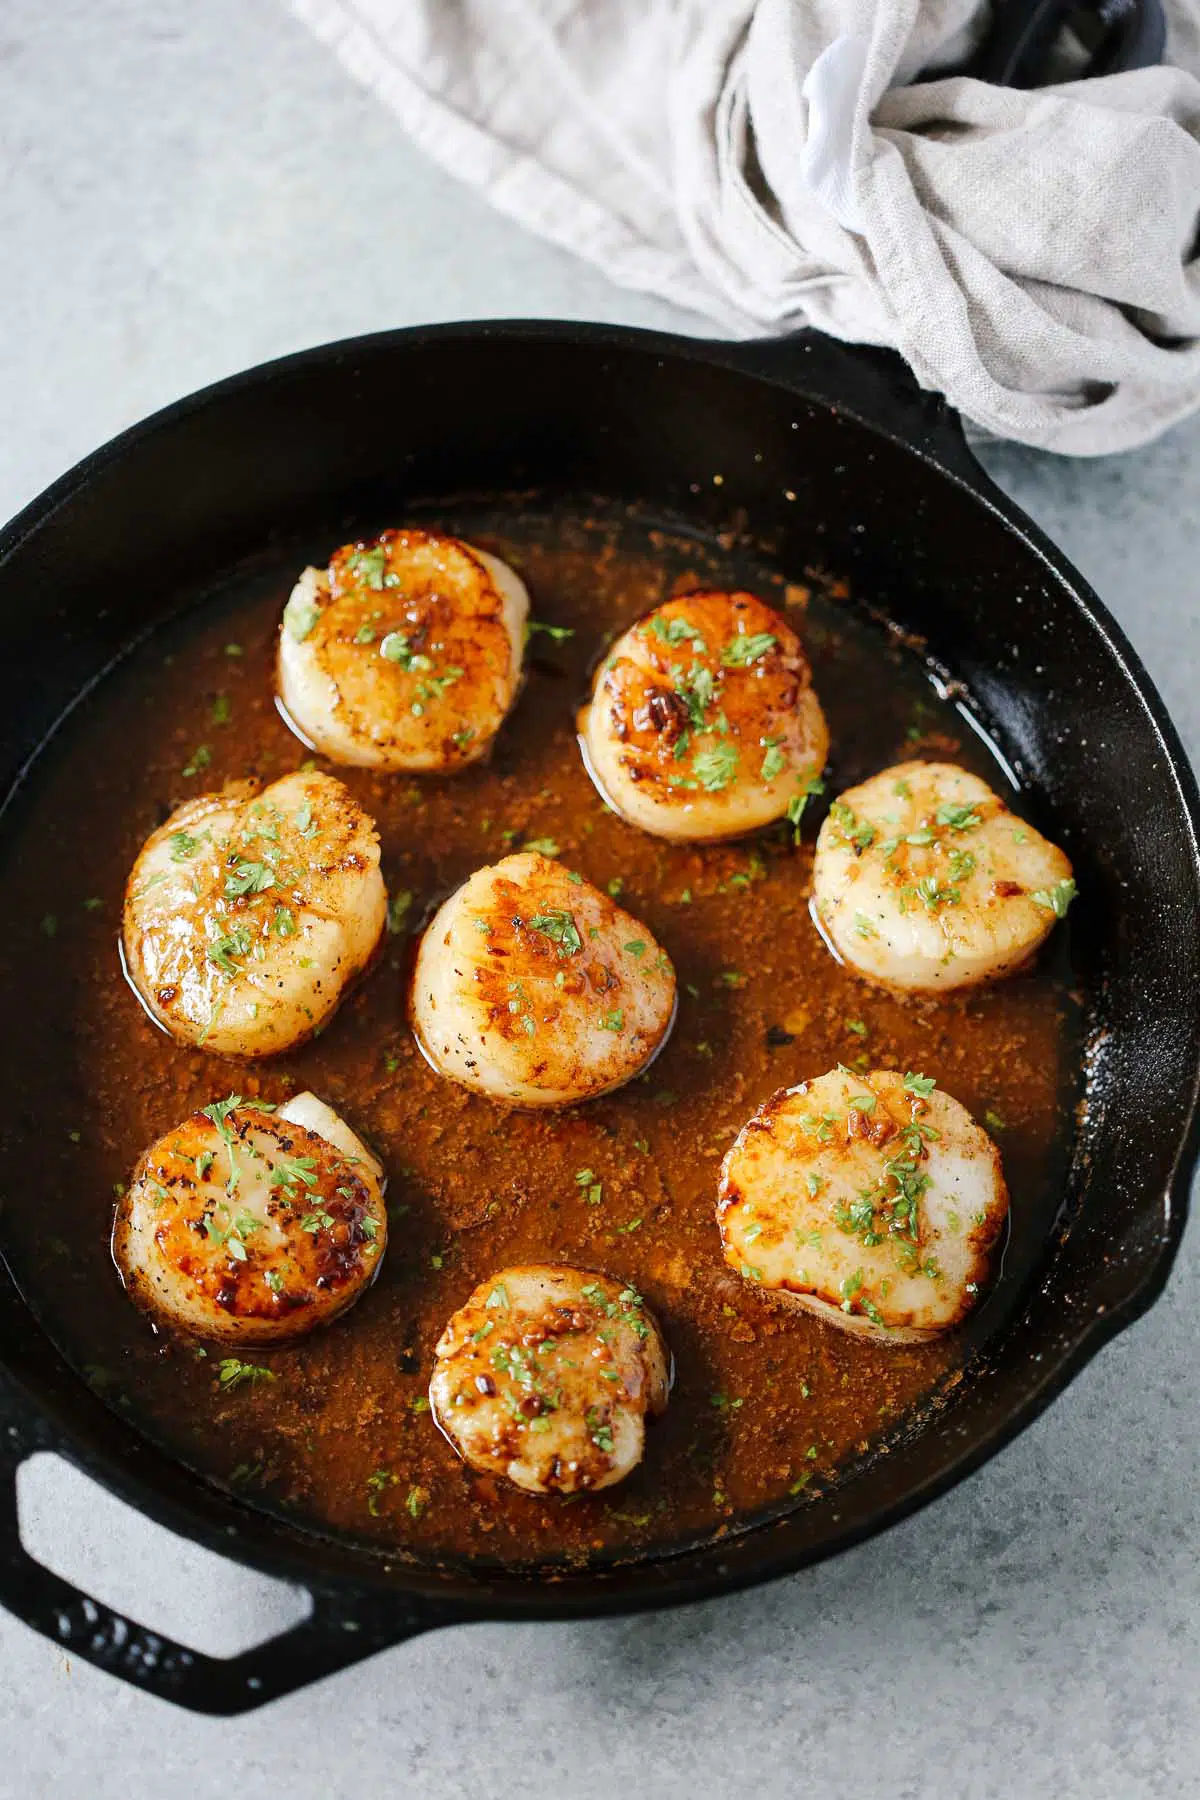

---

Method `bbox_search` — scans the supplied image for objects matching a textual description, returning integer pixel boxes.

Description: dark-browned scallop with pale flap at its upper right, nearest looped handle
[113,1093,387,1345]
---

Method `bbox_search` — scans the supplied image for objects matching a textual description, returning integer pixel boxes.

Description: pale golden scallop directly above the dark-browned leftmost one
[124,772,387,1057]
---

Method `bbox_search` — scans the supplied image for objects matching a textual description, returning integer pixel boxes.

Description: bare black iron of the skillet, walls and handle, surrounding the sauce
[0,324,1200,1714]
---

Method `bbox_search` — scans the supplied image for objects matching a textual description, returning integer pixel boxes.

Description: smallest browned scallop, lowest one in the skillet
[430,1265,671,1494]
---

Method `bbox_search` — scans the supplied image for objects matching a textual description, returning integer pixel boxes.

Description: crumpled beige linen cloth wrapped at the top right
[286,0,1200,455]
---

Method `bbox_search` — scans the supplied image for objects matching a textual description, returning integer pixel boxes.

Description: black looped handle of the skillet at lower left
[0,1384,456,1717]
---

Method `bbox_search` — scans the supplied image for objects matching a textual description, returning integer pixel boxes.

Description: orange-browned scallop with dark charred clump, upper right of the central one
[579,590,829,841]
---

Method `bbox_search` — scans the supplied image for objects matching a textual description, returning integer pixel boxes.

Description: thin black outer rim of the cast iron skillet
[0,319,1200,1677]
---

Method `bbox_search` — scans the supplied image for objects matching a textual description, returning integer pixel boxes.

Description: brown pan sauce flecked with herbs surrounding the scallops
[0,513,1079,1564]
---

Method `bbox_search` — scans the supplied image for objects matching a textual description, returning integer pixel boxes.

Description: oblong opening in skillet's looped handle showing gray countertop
[16,1451,313,1656]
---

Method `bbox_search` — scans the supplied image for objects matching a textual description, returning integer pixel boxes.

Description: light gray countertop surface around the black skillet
[0,0,1200,1800]
